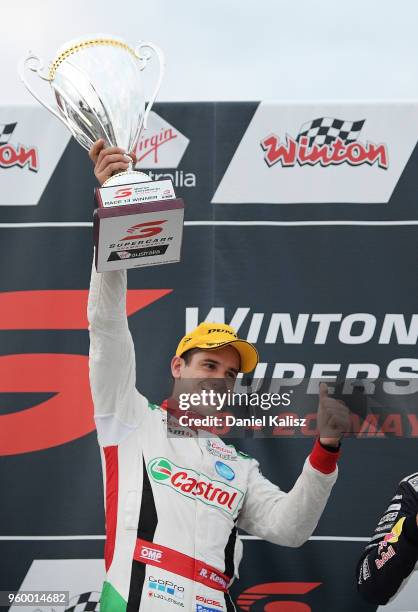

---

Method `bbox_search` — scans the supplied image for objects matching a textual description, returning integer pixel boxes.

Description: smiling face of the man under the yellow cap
[171,345,240,414]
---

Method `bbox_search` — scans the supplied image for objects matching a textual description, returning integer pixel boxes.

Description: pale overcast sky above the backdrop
[0,0,418,106]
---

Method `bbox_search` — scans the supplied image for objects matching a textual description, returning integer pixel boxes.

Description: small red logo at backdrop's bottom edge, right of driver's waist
[237,582,321,612]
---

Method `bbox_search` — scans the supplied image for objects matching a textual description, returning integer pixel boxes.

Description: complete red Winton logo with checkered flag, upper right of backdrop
[260,117,389,170]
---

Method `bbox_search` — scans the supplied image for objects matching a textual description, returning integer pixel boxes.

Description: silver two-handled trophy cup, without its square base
[19,35,164,185]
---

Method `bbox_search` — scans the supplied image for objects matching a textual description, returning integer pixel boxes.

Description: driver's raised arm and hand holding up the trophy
[87,141,146,446]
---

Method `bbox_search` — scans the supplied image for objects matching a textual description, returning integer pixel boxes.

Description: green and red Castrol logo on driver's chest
[148,457,243,516]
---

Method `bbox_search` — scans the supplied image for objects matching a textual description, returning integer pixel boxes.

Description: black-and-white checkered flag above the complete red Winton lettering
[296,117,365,147]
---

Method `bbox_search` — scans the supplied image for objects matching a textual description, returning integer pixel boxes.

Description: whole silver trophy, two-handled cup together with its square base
[19,35,184,272]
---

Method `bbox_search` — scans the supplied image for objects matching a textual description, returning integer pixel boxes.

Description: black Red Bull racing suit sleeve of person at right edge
[357,472,418,610]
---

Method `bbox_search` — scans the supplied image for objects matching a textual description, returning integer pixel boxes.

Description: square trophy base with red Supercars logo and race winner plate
[93,176,184,272]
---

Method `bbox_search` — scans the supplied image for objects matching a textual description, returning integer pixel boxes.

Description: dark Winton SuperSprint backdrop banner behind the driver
[0,102,418,612]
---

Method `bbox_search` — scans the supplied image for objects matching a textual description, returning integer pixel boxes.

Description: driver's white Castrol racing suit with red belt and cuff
[88,266,337,612]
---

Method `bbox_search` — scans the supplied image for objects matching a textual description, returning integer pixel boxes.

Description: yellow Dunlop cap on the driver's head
[176,323,258,373]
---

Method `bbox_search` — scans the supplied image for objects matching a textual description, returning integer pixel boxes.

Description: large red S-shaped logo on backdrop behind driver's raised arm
[0,289,172,455]
